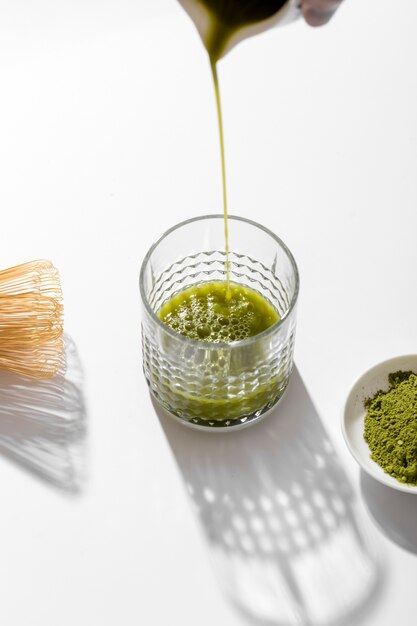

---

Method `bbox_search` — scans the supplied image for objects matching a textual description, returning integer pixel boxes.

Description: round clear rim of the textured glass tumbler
[139,213,300,350]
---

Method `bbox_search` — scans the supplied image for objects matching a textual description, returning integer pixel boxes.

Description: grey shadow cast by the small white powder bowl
[361,470,417,554]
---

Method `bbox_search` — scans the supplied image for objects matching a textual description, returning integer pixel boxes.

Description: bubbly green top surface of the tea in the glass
[158,281,279,343]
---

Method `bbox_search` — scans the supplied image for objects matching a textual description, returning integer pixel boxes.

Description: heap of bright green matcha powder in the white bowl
[364,372,417,485]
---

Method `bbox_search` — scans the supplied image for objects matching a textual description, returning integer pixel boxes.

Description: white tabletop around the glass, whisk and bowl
[0,0,417,626]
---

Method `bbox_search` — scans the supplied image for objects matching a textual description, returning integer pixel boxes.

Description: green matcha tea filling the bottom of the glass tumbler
[157,281,286,426]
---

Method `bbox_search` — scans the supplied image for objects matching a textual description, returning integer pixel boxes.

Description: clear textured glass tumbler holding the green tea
[140,215,299,429]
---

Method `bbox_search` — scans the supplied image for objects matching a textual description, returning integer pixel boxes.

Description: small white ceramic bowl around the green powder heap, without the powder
[342,354,417,494]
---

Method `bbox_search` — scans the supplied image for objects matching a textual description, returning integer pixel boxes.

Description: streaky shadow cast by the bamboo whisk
[0,336,87,493]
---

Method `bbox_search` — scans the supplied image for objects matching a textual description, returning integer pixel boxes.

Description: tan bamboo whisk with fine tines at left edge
[0,260,64,378]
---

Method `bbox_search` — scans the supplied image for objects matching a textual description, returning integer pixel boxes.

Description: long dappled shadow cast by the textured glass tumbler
[154,370,382,626]
